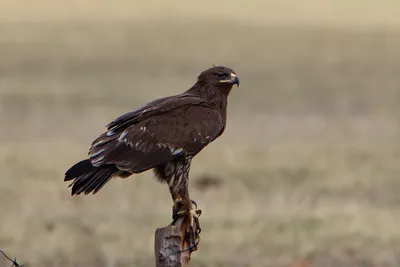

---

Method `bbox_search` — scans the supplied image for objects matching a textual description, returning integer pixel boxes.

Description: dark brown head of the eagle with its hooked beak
[198,66,239,90]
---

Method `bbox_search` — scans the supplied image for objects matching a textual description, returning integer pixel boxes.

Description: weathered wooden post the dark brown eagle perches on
[154,217,200,267]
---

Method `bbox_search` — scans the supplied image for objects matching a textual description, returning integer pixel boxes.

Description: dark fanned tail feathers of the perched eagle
[64,159,120,195]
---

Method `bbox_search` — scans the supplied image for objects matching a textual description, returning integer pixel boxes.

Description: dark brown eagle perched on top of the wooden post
[64,66,239,244]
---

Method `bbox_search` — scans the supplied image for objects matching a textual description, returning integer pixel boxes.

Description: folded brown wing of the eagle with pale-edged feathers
[89,95,224,172]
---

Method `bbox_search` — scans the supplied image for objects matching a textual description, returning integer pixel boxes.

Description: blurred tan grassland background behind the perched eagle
[0,0,400,267]
